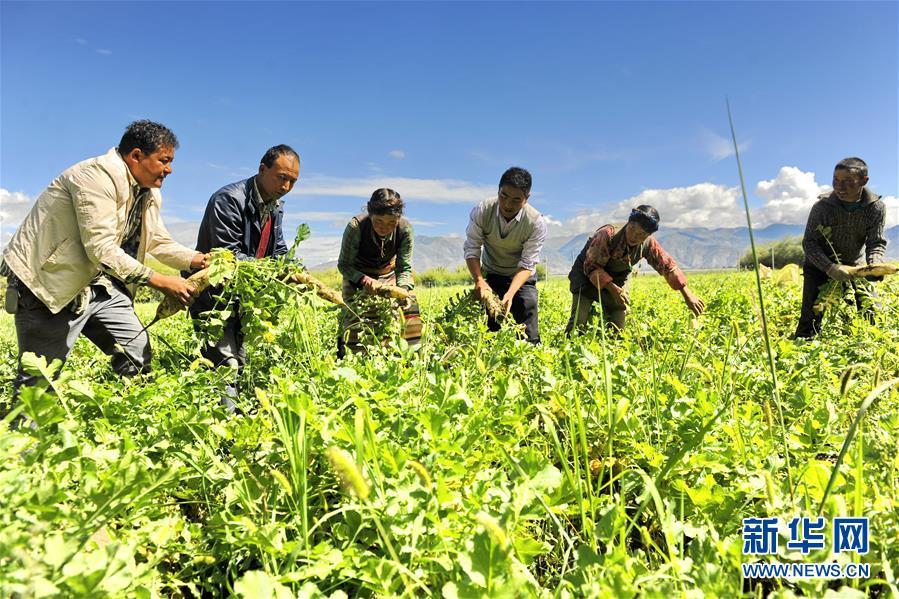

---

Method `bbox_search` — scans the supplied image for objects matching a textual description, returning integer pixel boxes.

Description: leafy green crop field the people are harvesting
[0,273,899,599]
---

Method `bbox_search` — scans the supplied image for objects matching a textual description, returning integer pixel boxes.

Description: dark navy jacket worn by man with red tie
[191,177,287,314]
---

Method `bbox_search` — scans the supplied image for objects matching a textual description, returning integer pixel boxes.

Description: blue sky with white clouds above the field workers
[0,1,899,263]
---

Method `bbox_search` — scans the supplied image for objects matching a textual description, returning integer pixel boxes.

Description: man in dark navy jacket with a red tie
[190,144,300,410]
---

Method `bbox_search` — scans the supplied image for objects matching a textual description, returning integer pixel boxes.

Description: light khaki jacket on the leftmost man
[3,148,196,314]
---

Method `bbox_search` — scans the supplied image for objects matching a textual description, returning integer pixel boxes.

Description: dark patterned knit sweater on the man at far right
[802,187,887,272]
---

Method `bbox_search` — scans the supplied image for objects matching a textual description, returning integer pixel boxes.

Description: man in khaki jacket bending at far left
[0,121,206,390]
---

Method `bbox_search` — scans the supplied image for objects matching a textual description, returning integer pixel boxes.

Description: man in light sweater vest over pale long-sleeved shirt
[464,166,546,343]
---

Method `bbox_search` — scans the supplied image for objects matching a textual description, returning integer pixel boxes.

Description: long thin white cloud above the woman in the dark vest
[291,176,496,204]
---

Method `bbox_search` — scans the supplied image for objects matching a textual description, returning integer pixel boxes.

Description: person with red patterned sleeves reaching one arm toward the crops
[565,205,705,335]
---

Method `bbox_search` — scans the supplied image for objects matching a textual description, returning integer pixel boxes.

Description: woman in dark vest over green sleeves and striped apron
[337,188,421,357]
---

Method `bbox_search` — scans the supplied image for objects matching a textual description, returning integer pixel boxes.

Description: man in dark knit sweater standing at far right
[793,158,887,338]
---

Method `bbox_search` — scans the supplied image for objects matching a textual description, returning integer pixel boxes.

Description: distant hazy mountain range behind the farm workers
[162,223,899,274]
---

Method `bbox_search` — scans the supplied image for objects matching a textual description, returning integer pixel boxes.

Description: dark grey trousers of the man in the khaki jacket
[13,283,151,392]
